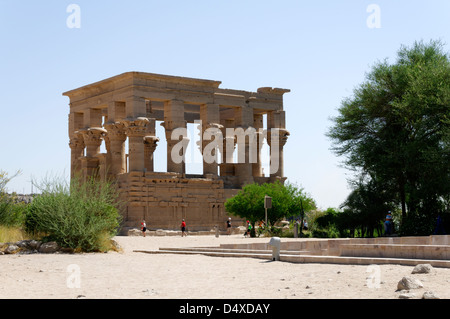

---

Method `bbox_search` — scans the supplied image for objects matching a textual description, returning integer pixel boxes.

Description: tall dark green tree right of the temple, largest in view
[327,41,450,229]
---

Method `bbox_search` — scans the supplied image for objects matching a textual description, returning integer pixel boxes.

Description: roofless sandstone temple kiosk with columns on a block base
[63,72,289,230]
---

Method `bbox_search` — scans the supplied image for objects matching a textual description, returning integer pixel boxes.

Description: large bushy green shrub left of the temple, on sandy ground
[25,179,120,252]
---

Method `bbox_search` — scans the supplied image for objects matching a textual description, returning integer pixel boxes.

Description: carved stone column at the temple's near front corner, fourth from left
[123,117,149,172]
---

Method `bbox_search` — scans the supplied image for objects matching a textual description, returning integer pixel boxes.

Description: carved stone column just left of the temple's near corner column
[104,122,127,177]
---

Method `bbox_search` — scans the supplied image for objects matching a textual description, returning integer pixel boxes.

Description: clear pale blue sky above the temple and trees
[0,0,450,209]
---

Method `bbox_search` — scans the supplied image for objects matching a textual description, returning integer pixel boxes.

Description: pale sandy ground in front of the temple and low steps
[0,235,450,299]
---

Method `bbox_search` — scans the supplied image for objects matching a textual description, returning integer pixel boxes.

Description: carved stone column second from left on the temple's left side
[80,127,106,180]
